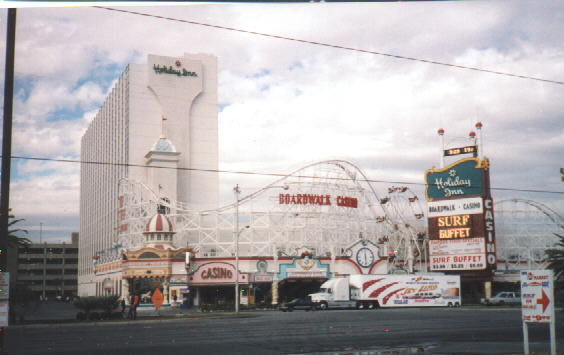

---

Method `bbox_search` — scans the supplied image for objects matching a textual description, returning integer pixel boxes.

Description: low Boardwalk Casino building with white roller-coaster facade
[94,157,426,305]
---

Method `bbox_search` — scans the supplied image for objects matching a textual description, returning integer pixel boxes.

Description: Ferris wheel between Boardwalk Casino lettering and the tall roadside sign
[380,186,427,272]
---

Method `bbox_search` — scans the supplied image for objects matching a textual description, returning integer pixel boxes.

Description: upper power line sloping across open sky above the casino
[93,6,564,85]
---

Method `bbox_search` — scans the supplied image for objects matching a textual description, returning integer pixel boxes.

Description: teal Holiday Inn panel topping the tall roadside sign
[425,158,487,201]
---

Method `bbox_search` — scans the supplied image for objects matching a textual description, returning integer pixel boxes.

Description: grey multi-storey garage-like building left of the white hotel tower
[14,233,79,300]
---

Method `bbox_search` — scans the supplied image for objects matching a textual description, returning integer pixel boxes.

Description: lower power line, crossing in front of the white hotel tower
[12,155,564,194]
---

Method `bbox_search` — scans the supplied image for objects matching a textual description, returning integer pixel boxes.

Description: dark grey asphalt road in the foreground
[6,307,564,355]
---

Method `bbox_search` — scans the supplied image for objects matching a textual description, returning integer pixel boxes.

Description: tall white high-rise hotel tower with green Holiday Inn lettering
[78,54,218,295]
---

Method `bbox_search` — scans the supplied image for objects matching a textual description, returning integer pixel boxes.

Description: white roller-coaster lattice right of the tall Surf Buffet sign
[494,199,564,270]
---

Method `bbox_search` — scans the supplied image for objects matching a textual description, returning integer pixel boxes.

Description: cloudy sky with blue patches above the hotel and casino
[0,1,564,241]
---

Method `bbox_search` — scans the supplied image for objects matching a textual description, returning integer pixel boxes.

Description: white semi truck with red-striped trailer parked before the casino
[309,274,461,310]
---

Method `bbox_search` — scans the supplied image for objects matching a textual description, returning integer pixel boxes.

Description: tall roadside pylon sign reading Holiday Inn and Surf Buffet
[425,158,496,271]
